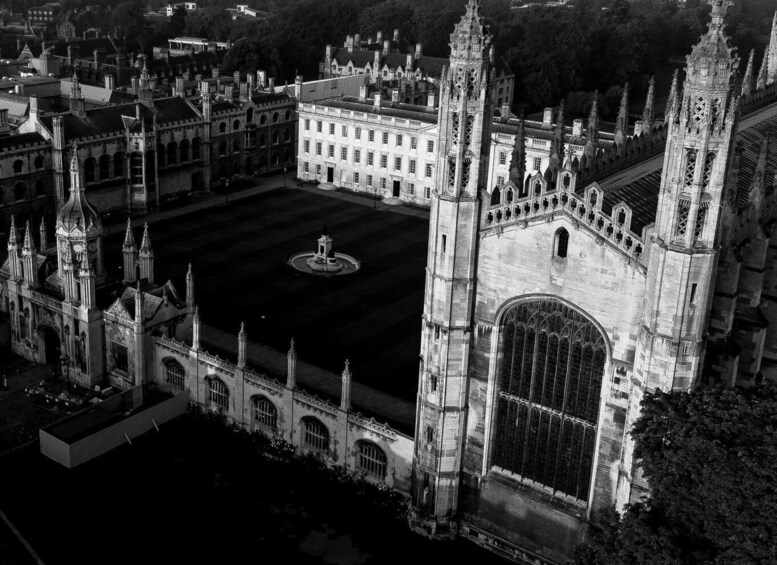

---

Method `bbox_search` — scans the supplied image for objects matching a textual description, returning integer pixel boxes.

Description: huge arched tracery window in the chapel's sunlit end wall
[492,299,607,501]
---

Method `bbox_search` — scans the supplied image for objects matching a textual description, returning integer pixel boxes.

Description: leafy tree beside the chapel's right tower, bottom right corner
[577,383,777,565]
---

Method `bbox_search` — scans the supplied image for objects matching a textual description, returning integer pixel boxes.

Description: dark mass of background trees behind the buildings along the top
[36,0,774,111]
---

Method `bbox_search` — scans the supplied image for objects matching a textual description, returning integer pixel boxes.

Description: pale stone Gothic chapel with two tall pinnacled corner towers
[412,0,777,563]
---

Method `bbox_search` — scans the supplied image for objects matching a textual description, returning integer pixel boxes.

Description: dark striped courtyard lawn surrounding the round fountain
[105,190,429,400]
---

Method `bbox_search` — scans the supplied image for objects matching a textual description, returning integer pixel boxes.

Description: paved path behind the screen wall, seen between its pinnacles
[200,324,415,434]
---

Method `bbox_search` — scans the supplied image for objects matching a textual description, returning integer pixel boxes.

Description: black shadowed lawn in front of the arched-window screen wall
[0,416,506,565]
